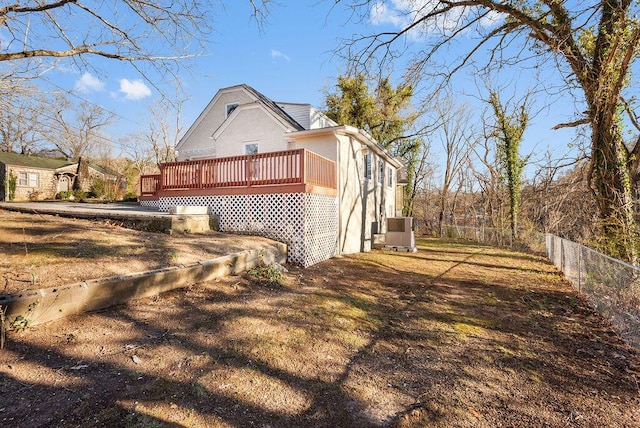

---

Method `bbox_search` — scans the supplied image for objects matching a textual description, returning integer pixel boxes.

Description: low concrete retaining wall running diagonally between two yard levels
[0,244,287,325]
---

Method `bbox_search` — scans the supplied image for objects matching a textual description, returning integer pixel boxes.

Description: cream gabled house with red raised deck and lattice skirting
[141,84,402,266]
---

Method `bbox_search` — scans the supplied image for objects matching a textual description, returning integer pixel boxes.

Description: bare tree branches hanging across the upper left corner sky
[0,0,272,84]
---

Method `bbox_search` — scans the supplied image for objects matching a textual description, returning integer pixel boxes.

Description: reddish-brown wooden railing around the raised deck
[140,149,337,196]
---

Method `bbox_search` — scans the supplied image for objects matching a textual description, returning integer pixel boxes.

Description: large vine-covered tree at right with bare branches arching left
[338,0,640,263]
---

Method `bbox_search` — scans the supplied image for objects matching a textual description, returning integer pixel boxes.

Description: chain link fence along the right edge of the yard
[440,226,640,349]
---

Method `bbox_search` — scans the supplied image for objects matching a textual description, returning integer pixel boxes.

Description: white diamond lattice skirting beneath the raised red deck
[151,193,338,267]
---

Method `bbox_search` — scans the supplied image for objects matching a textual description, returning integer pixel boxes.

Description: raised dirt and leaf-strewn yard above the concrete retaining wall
[0,210,278,293]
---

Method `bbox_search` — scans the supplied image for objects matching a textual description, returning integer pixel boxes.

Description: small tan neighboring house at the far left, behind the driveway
[0,152,122,201]
